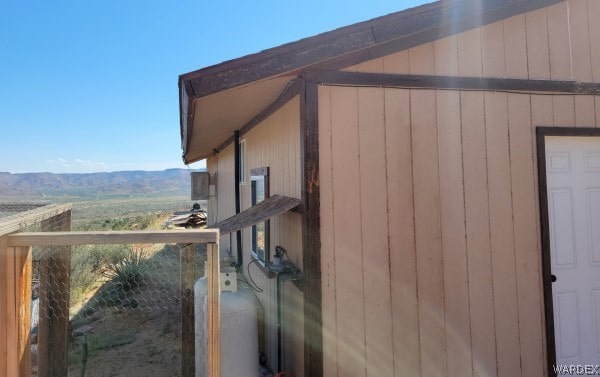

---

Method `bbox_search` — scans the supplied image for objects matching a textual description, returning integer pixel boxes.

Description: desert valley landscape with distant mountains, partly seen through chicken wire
[0,169,206,377]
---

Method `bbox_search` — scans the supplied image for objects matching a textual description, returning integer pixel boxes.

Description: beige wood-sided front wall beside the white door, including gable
[319,0,600,377]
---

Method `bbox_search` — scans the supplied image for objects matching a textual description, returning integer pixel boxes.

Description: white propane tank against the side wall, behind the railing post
[194,277,259,377]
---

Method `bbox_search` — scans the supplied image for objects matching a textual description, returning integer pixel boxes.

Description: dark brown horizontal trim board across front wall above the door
[306,70,600,96]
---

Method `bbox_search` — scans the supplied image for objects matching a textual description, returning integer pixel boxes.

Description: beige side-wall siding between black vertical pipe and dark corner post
[241,97,304,375]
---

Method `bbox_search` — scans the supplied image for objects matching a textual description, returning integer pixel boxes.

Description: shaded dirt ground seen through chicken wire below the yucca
[69,245,199,377]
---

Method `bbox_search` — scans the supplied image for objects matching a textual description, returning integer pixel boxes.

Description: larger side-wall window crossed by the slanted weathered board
[250,167,271,264]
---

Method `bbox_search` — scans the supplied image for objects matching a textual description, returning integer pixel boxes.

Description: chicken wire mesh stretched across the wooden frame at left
[0,201,219,377]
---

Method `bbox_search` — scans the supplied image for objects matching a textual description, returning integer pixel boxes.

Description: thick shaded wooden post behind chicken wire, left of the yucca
[38,211,71,377]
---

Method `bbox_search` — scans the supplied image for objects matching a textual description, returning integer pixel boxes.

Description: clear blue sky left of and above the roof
[0,0,430,173]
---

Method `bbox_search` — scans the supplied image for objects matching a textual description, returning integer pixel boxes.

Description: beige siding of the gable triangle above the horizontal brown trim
[344,0,600,82]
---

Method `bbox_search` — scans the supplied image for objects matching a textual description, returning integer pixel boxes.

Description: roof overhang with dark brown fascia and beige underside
[179,0,564,163]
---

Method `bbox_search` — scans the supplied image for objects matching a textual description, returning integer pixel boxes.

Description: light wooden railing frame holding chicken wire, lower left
[0,207,220,377]
